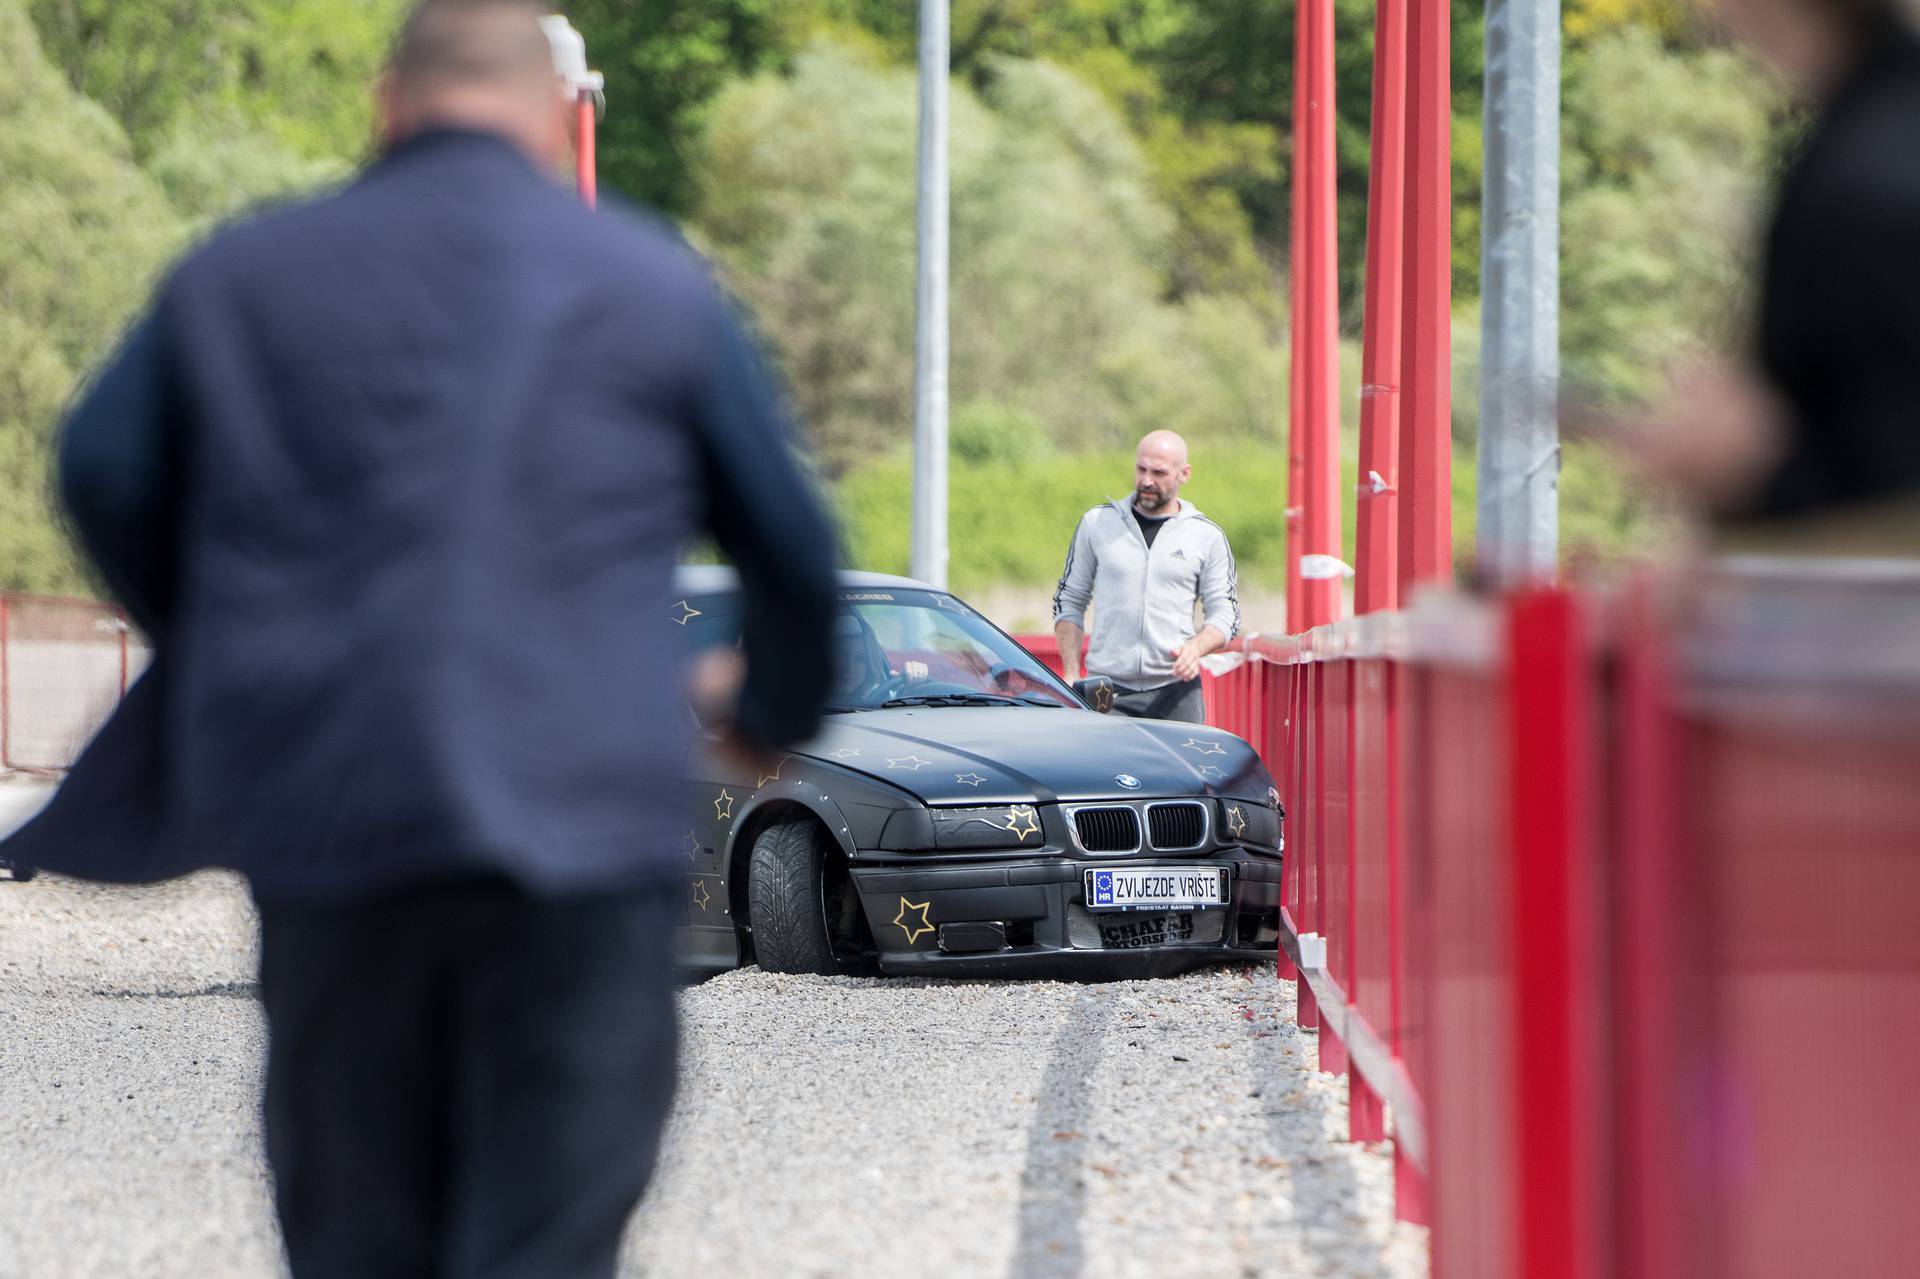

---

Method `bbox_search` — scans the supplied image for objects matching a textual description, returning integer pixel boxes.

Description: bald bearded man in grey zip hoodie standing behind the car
[1054,430,1240,724]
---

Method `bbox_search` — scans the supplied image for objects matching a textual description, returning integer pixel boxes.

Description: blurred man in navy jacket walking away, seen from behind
[0,0,831,1279]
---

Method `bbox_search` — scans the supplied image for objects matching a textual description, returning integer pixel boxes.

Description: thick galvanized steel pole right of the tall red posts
[1476,0,1561,584]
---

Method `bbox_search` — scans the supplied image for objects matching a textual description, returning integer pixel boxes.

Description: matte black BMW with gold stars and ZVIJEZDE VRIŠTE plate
[674,567,1281,977]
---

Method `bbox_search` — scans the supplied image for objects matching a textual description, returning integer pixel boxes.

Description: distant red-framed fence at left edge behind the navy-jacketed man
[0,595,146,772]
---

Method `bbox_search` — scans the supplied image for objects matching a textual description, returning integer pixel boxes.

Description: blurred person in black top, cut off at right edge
[1632,0,1920,553]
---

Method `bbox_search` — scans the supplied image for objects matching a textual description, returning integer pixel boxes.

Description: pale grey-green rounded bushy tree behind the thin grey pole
[695,44,1284,469]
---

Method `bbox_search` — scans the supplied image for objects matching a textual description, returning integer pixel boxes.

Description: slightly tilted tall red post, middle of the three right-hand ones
[1354,0,1407,613]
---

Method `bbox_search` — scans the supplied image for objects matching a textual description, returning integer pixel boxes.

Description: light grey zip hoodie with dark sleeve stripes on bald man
[1054,499,1240,689]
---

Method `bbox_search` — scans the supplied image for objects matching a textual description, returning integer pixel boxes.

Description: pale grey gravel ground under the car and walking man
[0,784,1427,1279]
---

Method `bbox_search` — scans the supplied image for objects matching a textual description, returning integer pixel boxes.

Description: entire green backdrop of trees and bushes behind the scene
[0,0,1795,606]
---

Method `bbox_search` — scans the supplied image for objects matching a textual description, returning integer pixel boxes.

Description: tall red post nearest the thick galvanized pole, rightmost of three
[1396,0,1453,599]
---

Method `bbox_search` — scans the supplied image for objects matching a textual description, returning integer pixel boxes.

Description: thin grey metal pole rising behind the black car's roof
[912,0,948,590]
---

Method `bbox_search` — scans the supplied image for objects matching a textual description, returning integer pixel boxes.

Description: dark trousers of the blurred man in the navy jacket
[259,881,678,1279]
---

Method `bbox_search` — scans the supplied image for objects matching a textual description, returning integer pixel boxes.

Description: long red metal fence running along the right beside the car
[1035,563,1920,1279]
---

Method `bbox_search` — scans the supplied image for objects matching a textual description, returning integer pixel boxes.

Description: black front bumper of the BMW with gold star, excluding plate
[852,849,1281,979]
